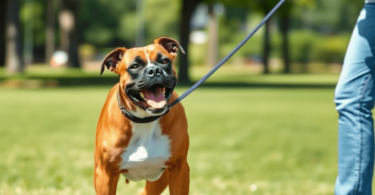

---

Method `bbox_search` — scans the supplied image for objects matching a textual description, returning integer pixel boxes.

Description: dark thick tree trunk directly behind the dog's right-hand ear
[178,0,201,82]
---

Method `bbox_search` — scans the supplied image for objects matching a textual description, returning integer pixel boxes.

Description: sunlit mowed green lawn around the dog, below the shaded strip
[0,75,337,195]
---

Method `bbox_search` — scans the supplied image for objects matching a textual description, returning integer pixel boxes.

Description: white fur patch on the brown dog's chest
[120,120,171,181]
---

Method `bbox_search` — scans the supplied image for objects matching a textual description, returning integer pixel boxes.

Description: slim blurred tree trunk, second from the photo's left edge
[45,1,55,64]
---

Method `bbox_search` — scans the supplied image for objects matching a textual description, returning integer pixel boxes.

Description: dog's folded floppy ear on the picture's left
[100,47,126,75]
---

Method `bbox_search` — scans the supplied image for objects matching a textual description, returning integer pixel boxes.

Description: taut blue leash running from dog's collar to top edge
[169,0,286,108]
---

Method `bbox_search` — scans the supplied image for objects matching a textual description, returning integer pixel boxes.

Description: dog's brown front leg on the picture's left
[94,165,120,195]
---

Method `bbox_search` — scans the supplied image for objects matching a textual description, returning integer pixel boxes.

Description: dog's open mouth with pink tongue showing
[129,84,173,109]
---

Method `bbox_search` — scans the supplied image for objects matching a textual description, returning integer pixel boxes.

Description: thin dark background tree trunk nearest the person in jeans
[281,15,290,73]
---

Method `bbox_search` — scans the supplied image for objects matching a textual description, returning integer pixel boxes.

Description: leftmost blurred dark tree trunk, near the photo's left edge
[5,0,25,73]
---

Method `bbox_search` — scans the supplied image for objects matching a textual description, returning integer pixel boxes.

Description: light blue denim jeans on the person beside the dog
[335,4,375,195]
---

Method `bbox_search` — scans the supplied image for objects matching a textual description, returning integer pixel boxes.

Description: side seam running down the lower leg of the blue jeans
[353,74,371,195]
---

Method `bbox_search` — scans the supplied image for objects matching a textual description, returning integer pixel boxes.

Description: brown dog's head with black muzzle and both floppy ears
[100,37,184,115]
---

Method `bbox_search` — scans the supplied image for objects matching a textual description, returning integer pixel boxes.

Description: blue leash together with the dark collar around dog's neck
[117,0,286,123]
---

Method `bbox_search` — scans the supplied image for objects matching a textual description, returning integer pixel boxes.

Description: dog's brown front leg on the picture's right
[169,159,190,195]
